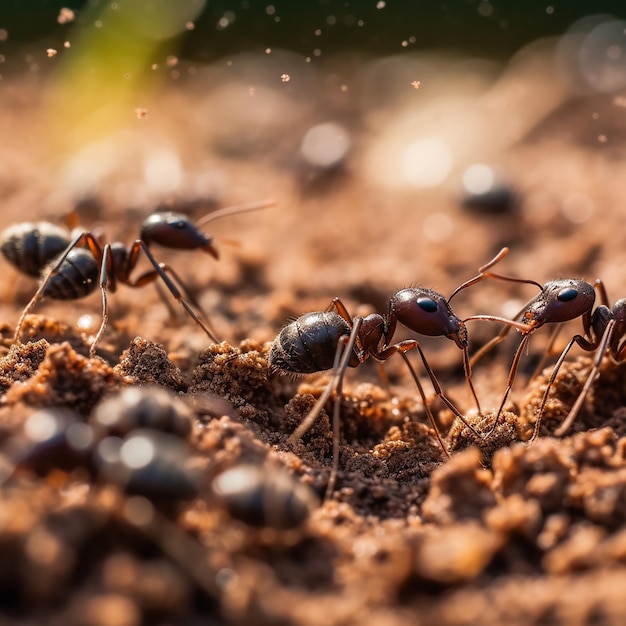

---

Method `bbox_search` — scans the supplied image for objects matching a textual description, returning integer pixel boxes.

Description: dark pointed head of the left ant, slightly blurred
[140,211,219,259]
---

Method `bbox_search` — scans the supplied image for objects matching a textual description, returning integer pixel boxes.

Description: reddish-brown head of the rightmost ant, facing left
[522,278,596,327]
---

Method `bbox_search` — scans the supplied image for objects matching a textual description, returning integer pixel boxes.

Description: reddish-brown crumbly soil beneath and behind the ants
[0,36,626,626]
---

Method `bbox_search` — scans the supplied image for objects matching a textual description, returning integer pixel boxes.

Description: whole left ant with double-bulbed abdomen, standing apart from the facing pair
[0,201,274,357]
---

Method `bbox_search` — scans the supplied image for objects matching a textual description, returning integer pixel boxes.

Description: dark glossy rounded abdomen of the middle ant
[268,311,359,374]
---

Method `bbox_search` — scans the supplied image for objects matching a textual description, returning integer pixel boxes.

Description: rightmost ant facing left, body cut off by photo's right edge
[463,248,596,442]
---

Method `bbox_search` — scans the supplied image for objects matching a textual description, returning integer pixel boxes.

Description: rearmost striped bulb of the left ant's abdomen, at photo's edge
[0,222,71,278]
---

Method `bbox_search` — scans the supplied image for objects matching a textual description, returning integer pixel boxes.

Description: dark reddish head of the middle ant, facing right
[389,287,467,348]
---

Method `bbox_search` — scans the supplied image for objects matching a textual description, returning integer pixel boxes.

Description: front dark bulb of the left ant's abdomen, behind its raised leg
[43,248,100,300]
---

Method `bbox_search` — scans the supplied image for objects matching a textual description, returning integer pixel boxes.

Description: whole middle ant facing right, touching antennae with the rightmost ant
[268,249,521,497]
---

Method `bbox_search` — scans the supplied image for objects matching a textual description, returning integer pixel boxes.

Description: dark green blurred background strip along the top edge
[0,0,626,62]
